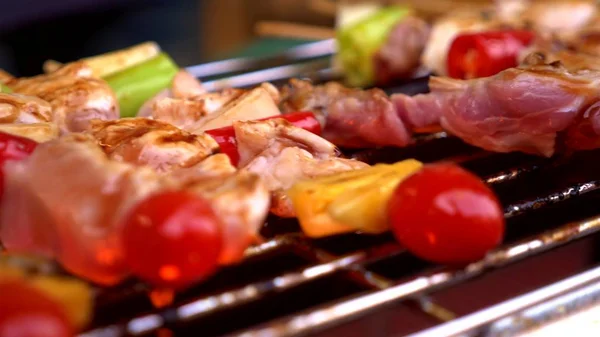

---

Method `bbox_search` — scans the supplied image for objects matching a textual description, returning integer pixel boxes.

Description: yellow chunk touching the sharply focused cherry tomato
[287,160,422,237]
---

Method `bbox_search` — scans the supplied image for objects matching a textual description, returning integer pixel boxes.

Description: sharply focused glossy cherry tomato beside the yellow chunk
[388,164,504,265]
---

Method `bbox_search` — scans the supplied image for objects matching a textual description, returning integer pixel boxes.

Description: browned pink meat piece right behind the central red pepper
[282,80,410,148]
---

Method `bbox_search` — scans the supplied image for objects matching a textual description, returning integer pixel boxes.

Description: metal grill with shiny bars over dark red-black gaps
[80,40,600,337]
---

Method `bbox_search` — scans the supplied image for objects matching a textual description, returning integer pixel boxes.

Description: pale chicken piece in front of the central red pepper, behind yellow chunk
[234,120,368,217]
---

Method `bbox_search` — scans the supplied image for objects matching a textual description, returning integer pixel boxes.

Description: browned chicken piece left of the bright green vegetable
[6,62,119,133]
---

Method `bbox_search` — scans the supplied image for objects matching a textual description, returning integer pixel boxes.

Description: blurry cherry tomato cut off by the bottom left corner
[0,281,74,337]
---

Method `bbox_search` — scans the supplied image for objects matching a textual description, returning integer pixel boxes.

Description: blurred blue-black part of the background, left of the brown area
[0,0,203,76]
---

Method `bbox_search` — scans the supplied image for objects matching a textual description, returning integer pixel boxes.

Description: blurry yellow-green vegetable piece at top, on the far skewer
[337,6,412,86]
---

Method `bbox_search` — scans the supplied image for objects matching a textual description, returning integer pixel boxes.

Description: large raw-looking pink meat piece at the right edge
[392,57,600,157]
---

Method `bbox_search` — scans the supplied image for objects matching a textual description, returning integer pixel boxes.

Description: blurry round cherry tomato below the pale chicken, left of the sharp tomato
[122,192,222,289]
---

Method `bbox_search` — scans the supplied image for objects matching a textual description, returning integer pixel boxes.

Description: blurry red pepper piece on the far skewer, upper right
[447,30,535,79]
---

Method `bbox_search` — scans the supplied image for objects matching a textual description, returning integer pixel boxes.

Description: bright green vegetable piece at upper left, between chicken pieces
[104,53,179,117]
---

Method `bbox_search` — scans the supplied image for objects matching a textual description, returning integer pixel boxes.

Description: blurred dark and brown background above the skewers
[0,0,491,76]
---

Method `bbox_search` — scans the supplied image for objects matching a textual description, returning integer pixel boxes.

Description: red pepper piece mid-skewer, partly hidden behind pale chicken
[206,112,321,166]
